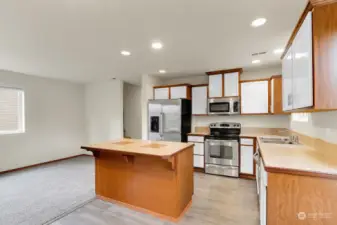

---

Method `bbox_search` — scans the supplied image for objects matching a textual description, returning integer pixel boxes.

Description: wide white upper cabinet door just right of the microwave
[241,80,269,114]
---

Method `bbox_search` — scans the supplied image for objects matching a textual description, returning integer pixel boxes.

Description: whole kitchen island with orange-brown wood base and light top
[81,139,194,221]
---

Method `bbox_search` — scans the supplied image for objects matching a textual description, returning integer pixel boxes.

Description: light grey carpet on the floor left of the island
[0,156,95,225]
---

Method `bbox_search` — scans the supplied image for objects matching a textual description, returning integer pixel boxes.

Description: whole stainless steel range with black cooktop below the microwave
[205,123,241,177]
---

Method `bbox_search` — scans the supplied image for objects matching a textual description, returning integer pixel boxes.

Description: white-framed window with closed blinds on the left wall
[0,87,25,135]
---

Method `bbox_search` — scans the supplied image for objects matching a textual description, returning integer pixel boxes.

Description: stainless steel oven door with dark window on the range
[205,139,239,166]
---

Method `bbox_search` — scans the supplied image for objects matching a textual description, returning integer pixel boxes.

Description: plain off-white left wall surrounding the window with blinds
[0,71,86,171]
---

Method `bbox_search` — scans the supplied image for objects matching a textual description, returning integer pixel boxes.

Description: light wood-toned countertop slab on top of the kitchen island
[81,139,194,157]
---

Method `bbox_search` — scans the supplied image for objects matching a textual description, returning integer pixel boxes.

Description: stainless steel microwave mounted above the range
[208,97,240,115]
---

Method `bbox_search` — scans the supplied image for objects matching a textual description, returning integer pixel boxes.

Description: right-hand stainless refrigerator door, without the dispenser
[162,100,181,134]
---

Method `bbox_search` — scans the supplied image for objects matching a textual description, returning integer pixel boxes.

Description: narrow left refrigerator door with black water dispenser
[148,102,162,141]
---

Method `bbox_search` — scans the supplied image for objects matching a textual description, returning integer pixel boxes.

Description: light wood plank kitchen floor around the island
[52,173,259,225]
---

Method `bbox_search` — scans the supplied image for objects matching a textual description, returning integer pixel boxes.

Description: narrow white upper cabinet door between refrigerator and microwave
[192,86,207,115]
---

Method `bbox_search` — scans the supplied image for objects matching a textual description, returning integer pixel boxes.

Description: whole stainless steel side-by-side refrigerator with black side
[148,99,192,142]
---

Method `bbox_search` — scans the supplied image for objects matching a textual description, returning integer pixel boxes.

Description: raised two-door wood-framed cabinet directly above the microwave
[206,68,242,98]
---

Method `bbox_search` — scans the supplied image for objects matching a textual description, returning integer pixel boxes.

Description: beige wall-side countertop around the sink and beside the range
[189,127,337,178]
